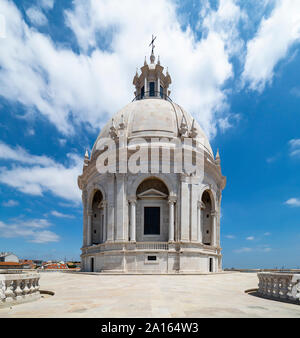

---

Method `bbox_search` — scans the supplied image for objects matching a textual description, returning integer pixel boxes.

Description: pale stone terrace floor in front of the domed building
[0,272,300,318]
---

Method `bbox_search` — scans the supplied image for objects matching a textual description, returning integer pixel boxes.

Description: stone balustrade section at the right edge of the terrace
[257,272,300,303]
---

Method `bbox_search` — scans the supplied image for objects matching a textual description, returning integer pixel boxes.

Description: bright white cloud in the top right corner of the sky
[243,0,300,91]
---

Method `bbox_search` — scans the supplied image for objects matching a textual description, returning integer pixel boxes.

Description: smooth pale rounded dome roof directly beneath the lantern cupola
[92,98,213,157]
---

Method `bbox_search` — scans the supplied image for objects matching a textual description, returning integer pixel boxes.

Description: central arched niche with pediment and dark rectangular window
[136,177,169,242]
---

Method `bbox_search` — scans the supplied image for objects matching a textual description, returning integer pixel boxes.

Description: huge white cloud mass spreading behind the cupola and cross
[0,0,240,136]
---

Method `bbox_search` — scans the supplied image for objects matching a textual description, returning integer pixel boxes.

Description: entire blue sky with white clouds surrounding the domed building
[0,0,300,268]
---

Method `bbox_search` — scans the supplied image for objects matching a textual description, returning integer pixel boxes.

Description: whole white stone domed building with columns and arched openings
[78,49,226,273]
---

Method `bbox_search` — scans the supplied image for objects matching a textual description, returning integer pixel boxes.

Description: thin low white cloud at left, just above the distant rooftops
[0,219,60,243]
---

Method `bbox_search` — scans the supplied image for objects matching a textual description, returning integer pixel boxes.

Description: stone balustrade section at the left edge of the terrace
[0,273,40,306]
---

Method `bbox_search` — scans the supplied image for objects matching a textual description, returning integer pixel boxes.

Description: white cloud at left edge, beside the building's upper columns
[0,143,82,203]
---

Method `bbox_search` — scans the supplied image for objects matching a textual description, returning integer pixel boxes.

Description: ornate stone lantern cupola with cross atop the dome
[133,38,172,100]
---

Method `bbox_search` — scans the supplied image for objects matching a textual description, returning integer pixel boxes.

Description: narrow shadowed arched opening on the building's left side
[91,190,104,244]
